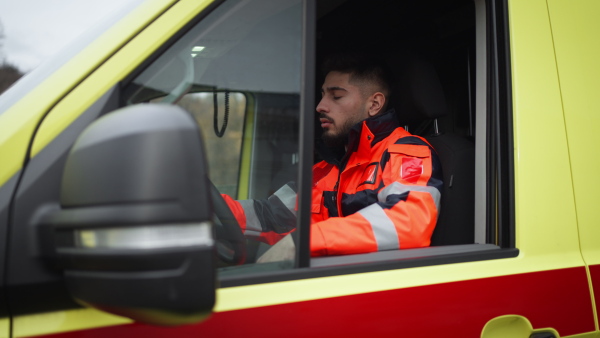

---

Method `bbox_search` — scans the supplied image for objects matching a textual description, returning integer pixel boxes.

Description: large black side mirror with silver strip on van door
[43,104,215,325]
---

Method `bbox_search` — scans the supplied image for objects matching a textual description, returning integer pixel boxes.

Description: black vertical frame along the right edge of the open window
[486,0,515,248]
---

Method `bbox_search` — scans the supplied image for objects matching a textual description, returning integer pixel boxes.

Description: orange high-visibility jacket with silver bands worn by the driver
[224,110,442,256]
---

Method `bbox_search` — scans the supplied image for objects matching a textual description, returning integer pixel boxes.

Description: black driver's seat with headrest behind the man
[392,56,475,246]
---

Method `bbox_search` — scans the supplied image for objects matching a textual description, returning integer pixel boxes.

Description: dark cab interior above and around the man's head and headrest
[315,0,475,141]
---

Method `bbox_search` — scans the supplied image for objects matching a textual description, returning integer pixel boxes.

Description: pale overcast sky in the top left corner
[0,0,140,72]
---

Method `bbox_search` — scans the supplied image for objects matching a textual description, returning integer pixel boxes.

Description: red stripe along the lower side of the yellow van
[35,267,600,338]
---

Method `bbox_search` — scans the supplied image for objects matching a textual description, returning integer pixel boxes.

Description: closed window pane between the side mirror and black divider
[123,0,302,274]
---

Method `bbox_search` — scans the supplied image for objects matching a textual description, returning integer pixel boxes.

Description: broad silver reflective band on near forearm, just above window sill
[358,204,400,251]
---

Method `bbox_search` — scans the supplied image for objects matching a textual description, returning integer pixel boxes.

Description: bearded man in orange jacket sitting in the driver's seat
[227,55,442,262]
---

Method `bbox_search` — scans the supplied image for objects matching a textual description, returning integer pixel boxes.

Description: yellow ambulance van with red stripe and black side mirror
[0,0,600,338]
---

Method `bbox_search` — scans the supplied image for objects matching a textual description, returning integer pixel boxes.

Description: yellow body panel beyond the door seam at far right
[547,0,600,265]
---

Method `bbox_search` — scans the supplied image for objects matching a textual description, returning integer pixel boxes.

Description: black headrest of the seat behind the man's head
[391,55,448,123]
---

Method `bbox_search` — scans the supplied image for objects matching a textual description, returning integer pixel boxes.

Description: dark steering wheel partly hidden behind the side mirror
[208,180,246,265]
